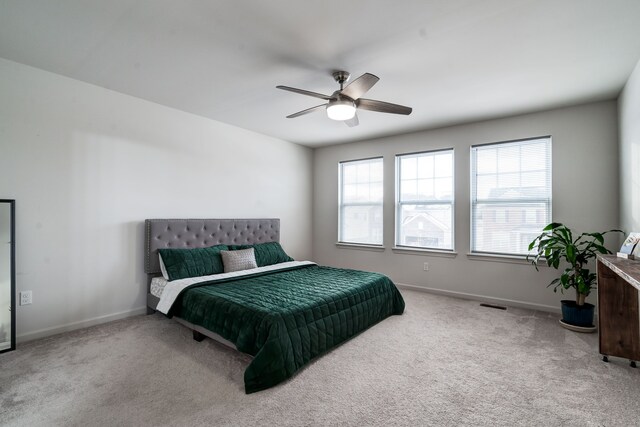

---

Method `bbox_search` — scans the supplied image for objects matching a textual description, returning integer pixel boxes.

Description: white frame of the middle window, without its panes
[394,147,456,254]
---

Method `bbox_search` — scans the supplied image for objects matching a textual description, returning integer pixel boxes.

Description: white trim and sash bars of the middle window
[392,147,457,252]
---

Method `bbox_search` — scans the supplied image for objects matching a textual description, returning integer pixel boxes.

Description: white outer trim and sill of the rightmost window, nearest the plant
[467,135,553,258]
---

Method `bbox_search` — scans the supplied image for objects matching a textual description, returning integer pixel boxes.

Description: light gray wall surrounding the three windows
[313,101,618,311]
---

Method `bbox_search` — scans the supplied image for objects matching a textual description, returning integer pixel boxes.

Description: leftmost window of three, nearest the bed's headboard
[338,157,383,245]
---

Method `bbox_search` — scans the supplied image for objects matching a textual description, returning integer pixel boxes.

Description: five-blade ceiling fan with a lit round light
[276,71,411,127]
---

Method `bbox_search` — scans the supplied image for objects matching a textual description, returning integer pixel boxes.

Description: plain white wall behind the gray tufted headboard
[0,59,313,340]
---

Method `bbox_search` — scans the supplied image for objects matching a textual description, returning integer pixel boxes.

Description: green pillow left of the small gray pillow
[158,245,229,280]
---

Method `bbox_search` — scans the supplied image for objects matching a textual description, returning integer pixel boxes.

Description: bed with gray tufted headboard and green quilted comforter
[145,219,404,393]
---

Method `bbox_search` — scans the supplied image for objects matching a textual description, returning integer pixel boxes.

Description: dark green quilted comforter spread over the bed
[169,265,404,393]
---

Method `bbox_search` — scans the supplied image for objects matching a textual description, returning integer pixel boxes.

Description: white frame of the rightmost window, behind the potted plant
[469,135,553,259]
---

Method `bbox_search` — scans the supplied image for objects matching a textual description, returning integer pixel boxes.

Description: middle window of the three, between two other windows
[396,149,454,250]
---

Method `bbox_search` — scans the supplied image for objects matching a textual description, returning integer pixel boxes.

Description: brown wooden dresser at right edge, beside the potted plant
[597,255,640,368]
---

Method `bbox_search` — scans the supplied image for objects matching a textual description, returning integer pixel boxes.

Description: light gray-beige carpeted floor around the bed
[0,290,640,426]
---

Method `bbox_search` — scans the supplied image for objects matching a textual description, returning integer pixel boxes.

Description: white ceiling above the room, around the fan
[0,0,640,147]
